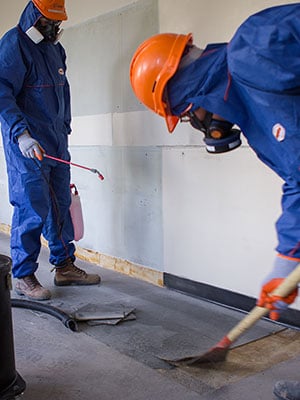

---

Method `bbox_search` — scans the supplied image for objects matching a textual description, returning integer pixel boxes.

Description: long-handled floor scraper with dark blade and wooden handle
[164,264,300,367]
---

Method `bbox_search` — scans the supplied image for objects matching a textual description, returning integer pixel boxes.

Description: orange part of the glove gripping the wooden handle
[257,278,298,321]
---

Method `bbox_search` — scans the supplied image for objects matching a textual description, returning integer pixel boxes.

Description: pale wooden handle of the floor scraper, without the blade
[227,264,300,343]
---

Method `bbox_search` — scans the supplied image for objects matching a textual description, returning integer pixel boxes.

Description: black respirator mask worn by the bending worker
[181,111,242,154]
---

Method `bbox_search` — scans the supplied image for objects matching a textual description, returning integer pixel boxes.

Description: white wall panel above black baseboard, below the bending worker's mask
[163,147,281,296]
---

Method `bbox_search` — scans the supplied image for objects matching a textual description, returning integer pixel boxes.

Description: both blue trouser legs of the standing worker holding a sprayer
[8,159,75,278]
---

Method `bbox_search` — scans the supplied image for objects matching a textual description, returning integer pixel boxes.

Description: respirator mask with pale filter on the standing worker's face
[26,17,63,44]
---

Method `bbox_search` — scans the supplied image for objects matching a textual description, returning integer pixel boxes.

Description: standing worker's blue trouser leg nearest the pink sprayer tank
[43,159,75,265]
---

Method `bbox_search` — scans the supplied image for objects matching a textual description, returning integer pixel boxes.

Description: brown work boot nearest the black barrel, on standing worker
[15,274,51,300]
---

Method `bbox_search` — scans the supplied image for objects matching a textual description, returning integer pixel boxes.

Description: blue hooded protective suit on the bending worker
[167,3,300,259]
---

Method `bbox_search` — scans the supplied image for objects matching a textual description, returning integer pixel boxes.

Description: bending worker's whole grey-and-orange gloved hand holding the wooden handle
[257,256,299,320]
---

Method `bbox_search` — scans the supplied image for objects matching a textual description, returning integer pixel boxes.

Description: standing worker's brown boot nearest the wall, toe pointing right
[54,258,101,286]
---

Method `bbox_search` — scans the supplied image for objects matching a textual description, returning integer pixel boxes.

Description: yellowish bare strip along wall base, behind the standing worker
[0,223,163,286]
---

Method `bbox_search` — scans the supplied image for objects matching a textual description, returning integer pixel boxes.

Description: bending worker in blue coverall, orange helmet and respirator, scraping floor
[130,3,300,400]
